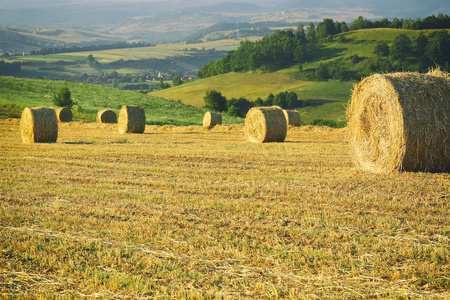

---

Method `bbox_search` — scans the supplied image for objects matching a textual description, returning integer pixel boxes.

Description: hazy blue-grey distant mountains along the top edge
[0,0,449,44]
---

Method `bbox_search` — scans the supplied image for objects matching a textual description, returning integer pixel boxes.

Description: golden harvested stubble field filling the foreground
[0,120,450,299]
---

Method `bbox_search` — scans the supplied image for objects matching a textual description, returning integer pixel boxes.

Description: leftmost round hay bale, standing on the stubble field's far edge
[20,107,58,143]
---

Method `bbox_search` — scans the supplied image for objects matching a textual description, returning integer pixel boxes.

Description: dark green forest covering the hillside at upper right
[197,15,450,80]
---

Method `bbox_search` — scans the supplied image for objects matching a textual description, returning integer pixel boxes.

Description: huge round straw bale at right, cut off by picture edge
[347,71,450,173]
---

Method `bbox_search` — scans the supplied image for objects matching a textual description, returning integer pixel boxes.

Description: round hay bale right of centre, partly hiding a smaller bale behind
[244,106,287,143]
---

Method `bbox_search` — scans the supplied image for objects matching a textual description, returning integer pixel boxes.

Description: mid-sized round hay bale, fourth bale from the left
[118,105,145,134]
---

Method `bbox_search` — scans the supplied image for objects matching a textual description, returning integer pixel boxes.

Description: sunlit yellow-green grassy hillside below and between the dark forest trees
[152,29,448,124]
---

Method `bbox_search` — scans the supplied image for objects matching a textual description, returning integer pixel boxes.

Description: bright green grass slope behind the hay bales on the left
[0,77,243,125]
